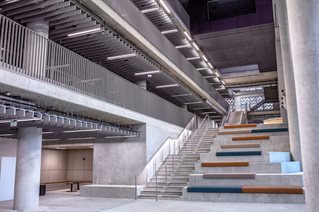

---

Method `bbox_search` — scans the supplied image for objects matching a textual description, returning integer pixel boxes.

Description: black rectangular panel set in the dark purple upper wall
[207,0,256,21]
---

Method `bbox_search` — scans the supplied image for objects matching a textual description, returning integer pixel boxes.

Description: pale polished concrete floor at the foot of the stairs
[0,191,306,212]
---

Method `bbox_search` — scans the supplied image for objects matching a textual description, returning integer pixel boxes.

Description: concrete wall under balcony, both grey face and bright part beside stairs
[93,121,183,185]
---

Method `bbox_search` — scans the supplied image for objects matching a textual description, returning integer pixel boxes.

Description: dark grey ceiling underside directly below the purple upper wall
[194,23,276,72]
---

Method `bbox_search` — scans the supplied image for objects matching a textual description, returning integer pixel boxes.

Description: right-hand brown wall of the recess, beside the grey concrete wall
[67,149,93,181]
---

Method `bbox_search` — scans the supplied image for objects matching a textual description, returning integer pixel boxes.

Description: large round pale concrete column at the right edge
[287,0,319,212]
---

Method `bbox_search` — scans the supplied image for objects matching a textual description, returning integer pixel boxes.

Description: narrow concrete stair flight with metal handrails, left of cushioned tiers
[139,129,217,199]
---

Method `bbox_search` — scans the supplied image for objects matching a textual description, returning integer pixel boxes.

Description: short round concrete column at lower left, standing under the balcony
[13,127,42,211]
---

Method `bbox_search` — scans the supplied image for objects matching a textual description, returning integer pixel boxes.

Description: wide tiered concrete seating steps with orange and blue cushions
[182,125,305,203]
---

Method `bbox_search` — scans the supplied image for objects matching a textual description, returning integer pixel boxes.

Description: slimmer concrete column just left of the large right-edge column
[275,0,301,161]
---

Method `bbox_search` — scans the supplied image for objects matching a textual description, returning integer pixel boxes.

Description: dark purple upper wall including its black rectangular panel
[188,0,273,35]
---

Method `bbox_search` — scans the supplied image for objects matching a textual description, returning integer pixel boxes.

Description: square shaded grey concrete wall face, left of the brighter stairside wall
[93,125,146,185]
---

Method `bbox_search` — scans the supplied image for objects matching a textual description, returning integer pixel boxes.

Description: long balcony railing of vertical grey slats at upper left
[0,15,191,125]
